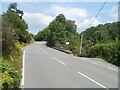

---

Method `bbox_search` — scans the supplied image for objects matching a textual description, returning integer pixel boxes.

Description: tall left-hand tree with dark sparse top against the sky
[5,3,32,43]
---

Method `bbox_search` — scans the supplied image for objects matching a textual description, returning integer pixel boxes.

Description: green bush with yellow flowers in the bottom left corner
[0,60,20,90]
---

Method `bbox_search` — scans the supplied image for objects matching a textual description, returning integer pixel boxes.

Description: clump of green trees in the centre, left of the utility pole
[34,14,77,50]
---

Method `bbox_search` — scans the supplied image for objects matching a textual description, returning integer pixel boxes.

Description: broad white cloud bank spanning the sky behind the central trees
[23,5,100,34]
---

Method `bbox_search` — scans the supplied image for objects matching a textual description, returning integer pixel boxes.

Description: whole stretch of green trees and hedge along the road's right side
[35,14,120,65]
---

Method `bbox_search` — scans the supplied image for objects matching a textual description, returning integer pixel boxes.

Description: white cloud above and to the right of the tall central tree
[45,5,101,32]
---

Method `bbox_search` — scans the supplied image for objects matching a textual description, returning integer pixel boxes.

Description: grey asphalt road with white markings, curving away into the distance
[23,42,118,88]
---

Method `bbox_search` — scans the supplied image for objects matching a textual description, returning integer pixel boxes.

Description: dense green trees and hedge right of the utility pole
[80,22,120,65]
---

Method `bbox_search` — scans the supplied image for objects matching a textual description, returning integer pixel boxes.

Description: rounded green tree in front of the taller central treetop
[48,20,66,46]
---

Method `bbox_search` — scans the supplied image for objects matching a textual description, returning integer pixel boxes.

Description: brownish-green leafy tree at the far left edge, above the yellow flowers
[2,15,18,56]
